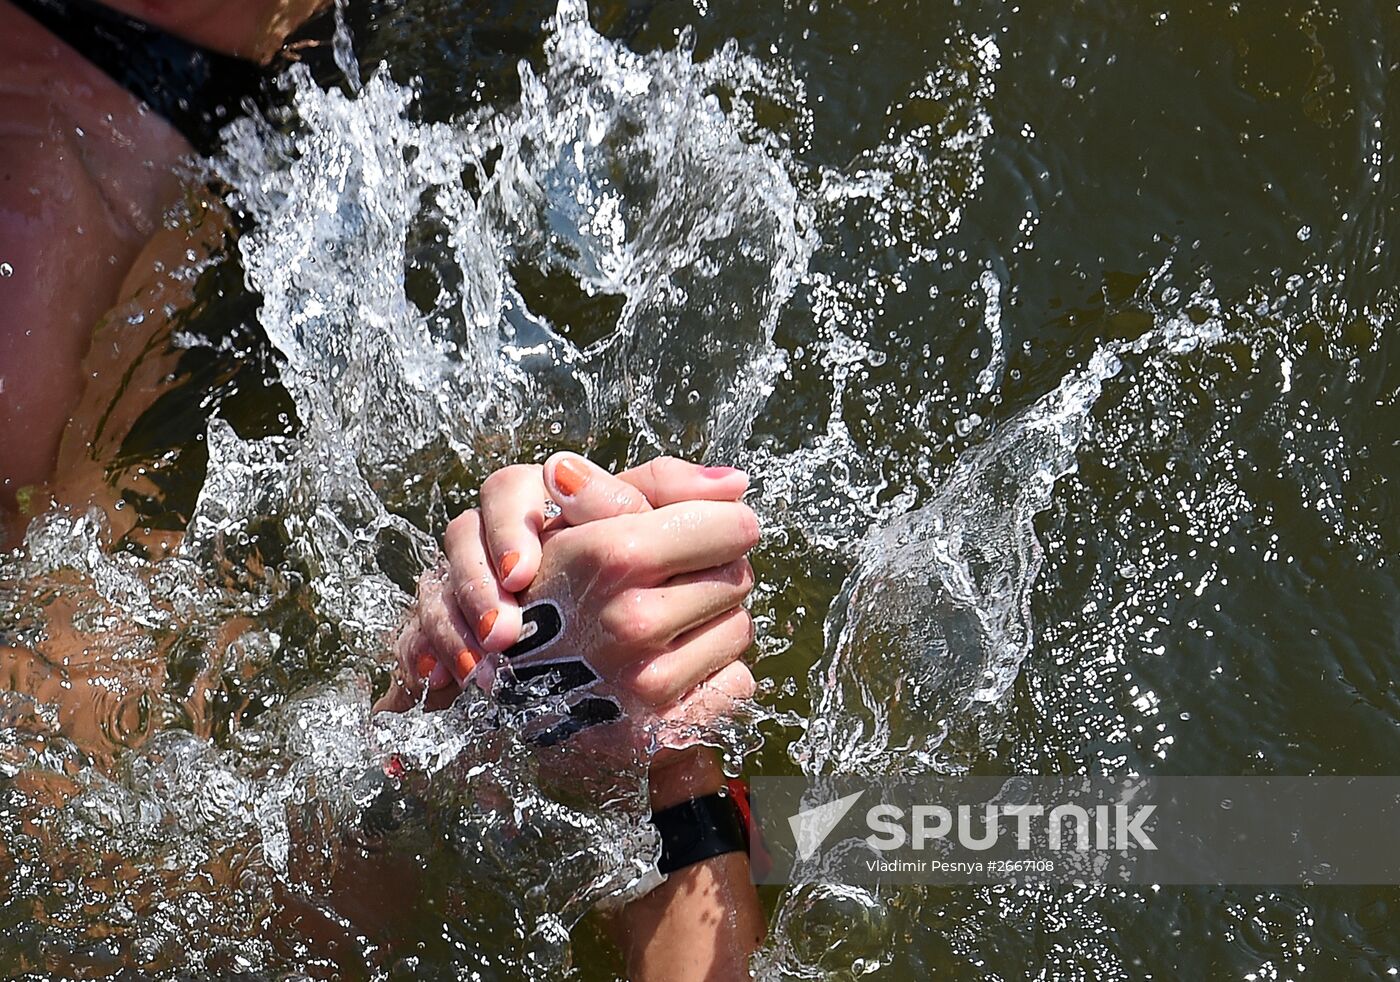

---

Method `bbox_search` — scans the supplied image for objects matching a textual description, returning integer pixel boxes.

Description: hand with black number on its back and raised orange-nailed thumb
[498,455,759,747]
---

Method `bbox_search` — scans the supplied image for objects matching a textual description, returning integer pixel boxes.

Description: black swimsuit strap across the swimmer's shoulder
[10,0,265,154]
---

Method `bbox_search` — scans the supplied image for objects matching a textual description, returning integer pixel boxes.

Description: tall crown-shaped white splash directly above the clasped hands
[217,3,811,479]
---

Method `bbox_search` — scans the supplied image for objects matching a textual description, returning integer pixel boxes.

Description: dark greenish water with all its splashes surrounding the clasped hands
[0,0,1400,979]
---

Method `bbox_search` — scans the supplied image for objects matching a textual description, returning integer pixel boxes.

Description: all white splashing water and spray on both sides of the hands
[0,0,1385,978]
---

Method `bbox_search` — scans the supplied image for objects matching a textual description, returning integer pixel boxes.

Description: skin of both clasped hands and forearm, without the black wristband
[379,454,764,982]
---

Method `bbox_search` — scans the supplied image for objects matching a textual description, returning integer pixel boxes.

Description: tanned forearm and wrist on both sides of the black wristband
[613,751,764,982]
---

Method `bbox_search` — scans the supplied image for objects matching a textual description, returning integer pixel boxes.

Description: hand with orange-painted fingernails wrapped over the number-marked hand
[379,454,748,709]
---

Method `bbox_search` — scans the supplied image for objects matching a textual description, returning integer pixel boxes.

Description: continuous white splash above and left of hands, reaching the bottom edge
[0,0,813,978]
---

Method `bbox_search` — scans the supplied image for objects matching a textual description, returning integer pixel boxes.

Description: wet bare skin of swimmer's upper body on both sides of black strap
[0,0,312,548]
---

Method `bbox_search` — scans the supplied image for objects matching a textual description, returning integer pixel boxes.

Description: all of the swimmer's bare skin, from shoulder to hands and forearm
[0,0,762,979]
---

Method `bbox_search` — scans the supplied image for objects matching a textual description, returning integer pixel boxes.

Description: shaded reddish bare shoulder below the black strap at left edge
[0,0,189,529]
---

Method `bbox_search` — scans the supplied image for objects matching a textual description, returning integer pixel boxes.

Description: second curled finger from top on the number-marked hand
[598,559,753,651]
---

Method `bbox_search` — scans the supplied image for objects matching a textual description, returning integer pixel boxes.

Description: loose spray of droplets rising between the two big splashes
[742,29,1004,560]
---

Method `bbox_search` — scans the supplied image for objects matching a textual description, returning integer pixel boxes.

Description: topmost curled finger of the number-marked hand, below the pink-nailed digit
[574,502,759,586]
